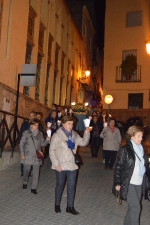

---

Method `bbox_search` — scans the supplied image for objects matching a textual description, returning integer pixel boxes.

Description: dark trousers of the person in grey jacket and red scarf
[104,150,117,168]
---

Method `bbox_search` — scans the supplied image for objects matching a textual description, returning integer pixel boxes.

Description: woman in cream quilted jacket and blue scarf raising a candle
[49,115,90,215]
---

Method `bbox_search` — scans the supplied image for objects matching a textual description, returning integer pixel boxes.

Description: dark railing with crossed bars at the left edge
[0,110,28,158]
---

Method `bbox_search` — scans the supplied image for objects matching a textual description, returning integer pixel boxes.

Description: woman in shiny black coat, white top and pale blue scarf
[113,126,147,225]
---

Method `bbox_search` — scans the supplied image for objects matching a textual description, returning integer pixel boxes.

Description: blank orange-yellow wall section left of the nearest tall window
[0,0,29,89]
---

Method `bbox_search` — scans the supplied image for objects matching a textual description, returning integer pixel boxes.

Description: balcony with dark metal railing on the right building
[116,65,141,83]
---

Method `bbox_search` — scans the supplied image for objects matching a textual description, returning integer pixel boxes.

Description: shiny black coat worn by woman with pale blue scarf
[112,140,148,201]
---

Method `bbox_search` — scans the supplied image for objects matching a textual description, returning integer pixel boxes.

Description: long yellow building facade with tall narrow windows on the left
[0,0,95,119]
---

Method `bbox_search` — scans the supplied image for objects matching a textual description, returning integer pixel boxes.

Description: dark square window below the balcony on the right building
[128,93,143,109]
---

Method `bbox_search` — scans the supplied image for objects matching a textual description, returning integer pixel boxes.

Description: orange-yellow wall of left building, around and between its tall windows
[0,0,94,110]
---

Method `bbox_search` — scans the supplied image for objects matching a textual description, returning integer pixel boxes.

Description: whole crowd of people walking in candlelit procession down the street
[18,104,150,225]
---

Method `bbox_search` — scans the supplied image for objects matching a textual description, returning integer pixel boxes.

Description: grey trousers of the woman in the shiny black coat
[124,184,142,225]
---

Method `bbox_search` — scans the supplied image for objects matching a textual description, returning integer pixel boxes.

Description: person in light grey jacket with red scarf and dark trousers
[100,118,121,170]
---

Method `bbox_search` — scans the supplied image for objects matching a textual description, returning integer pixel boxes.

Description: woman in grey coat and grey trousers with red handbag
[20,119,50,194]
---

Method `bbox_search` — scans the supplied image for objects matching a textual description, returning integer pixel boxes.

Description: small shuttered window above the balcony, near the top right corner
[127,11,142,27]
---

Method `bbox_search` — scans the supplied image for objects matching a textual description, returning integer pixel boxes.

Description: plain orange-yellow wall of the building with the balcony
[103,0,150,109]
